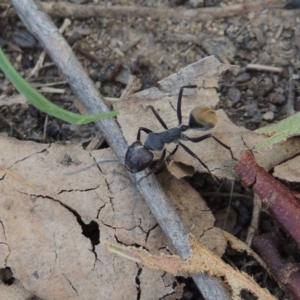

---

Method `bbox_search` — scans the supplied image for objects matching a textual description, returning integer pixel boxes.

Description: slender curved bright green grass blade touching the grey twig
[0,47,119,124]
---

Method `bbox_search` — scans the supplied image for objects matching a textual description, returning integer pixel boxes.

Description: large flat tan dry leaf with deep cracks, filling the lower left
[0,137,226,300]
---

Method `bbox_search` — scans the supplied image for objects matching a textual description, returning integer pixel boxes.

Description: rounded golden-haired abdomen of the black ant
[189,106,218,131]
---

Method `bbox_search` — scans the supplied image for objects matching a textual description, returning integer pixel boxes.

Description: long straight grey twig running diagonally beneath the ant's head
[8,0,230,299]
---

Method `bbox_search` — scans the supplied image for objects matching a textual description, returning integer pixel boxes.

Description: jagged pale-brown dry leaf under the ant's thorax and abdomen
[115,56,300,179]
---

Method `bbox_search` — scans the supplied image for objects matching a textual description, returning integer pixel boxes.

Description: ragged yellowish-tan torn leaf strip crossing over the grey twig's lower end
[106,234,276,300]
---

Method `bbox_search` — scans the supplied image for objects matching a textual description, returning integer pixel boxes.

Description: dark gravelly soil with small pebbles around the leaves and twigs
[0,0,300,300]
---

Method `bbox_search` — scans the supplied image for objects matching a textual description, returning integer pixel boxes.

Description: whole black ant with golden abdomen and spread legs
[125,85,233,178]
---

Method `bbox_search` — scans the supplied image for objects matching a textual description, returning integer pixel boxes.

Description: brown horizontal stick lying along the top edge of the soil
[2,0,282,21]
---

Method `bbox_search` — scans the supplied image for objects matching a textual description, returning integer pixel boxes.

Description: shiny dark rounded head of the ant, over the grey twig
[125,141,154,173]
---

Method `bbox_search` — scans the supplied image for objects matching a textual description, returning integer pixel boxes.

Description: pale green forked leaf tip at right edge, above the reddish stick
[255,113,300,149]
